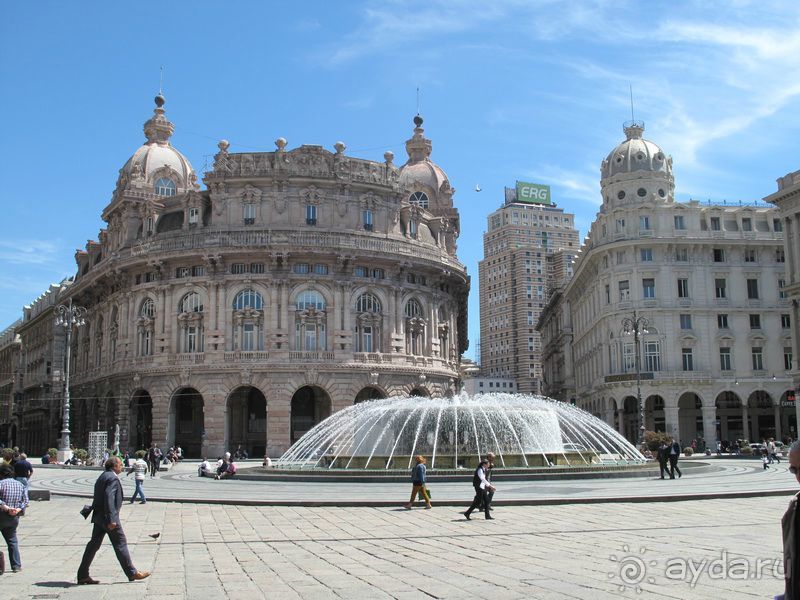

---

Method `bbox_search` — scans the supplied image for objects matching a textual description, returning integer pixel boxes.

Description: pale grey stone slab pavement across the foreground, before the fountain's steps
[0,496,788,600]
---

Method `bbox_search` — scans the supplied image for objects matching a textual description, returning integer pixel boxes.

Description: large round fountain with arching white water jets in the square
[275,394,645,471]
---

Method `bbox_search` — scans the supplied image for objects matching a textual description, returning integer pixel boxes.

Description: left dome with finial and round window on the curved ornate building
[119,94,198,192]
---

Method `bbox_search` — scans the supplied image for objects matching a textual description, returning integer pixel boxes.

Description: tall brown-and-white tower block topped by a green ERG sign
[478,182,580,393]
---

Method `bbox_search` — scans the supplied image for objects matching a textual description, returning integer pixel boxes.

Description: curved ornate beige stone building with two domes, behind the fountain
[50,96,469,456]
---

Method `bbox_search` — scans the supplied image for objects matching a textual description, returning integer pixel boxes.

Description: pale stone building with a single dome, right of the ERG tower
[538,123,798,444]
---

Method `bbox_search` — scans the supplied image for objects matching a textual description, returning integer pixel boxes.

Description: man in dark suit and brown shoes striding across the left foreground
[78,456,150,585]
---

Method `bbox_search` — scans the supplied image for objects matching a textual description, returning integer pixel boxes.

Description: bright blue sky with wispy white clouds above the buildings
[0,0,800,356]
